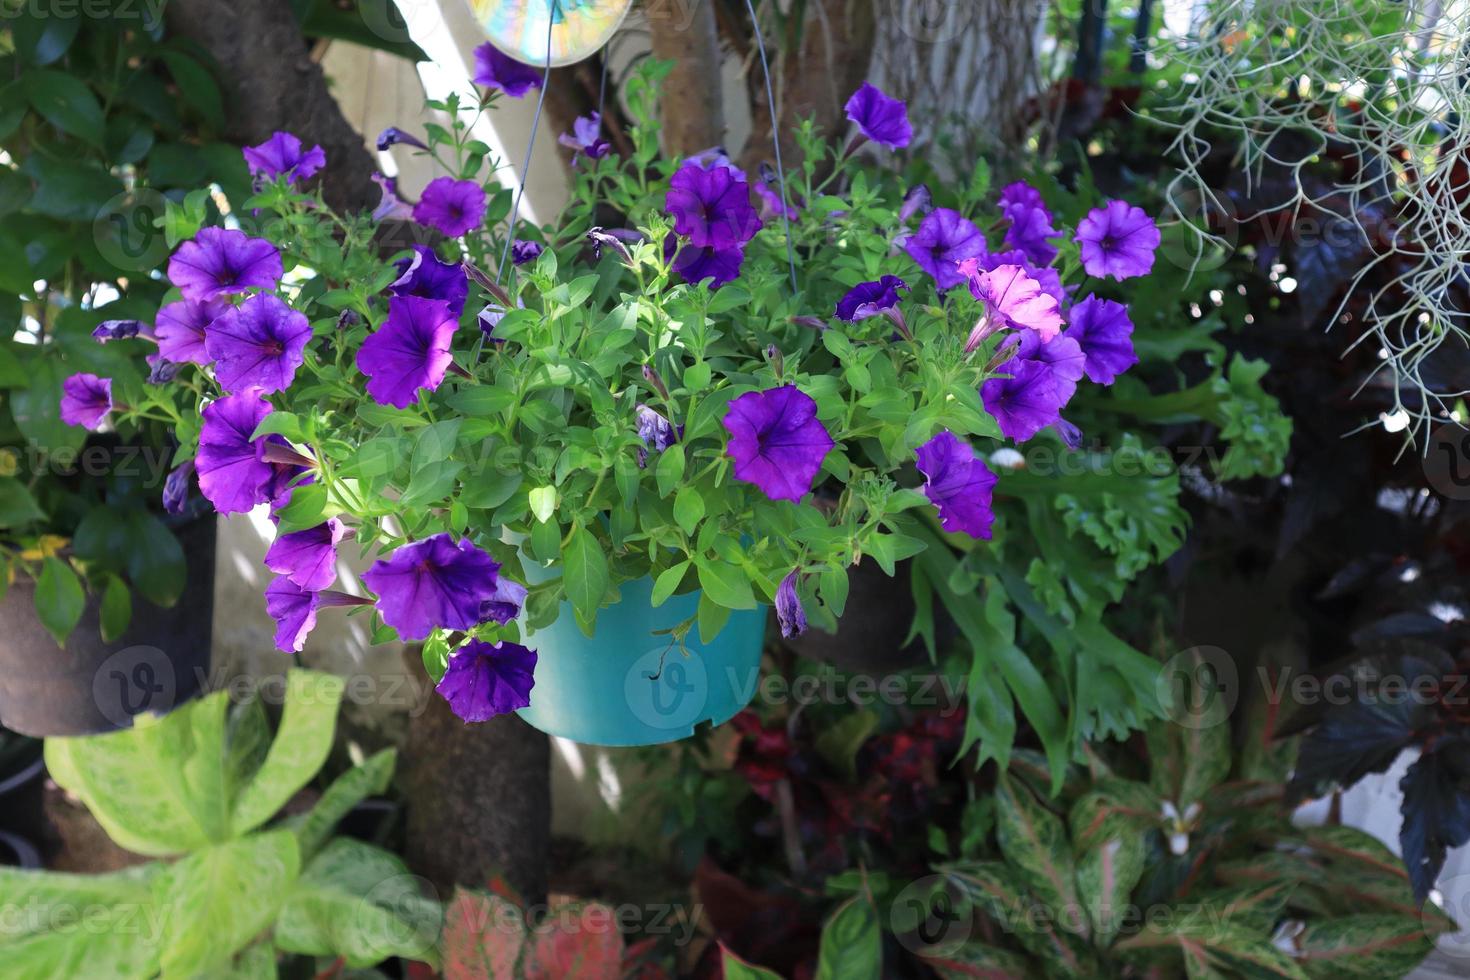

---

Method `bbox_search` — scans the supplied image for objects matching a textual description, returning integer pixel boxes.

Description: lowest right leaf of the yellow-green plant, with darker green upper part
[273,837,442,970]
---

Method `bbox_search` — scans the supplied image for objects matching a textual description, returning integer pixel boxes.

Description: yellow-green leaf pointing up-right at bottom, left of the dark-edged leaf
[154,828,301,977]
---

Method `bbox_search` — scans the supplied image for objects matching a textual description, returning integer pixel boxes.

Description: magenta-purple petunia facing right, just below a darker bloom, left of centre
[357,295,459,408]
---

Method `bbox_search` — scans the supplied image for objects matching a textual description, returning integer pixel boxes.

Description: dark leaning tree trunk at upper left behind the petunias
[168,0,379,212]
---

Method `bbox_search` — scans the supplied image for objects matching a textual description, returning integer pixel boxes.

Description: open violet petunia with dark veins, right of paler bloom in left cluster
[204,292,312,395]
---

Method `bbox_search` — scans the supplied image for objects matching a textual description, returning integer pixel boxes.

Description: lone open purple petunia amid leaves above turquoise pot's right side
[720,385,835,501]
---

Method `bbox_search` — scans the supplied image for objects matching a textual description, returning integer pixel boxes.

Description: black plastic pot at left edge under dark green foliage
[0,514,215,738]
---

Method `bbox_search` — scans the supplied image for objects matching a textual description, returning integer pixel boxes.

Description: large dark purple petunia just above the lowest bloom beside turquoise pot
[363,535,500,639]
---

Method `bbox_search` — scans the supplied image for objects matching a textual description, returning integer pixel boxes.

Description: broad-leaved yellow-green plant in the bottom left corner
[0,670,442,980]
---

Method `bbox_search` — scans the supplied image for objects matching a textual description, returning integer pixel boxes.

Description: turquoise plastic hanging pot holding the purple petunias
[520,579,766,745]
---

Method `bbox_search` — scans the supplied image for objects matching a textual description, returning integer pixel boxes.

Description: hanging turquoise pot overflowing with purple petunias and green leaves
[74,50,1158,743]
